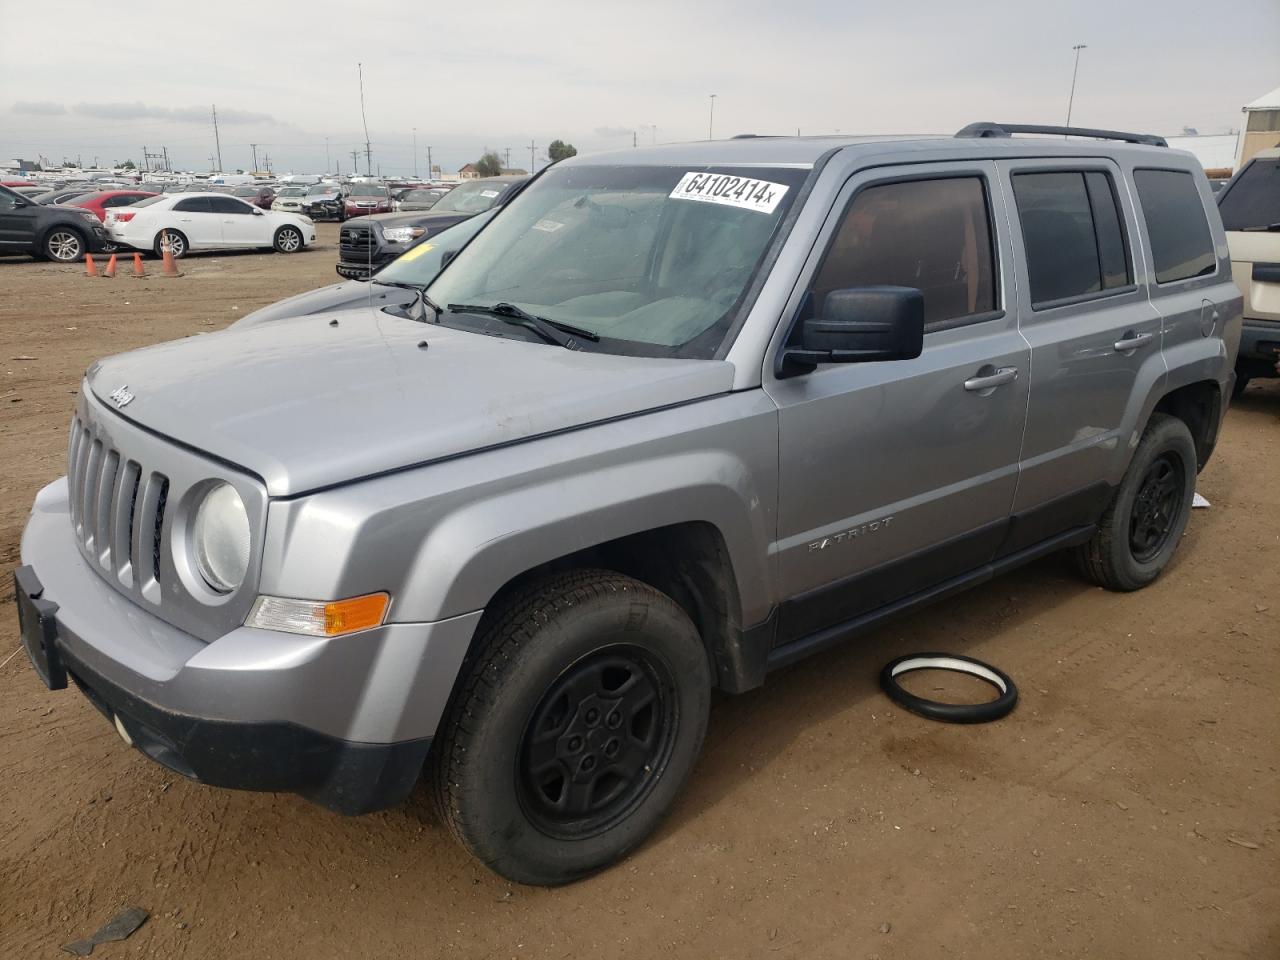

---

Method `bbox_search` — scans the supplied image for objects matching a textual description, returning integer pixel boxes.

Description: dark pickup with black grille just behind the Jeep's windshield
[337,177,529,280]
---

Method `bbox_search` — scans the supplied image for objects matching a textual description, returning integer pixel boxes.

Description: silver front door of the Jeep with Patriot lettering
[765,161,1029,644]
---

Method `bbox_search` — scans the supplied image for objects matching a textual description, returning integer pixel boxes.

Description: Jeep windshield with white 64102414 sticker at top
[428,166,808,357]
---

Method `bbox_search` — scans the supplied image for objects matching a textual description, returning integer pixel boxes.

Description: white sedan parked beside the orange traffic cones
[106,192,316,257]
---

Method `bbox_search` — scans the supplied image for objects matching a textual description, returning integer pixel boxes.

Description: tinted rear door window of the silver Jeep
[1012,170,1133,307]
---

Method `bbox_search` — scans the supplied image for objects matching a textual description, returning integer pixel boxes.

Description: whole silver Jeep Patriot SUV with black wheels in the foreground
[15,123,1242,884]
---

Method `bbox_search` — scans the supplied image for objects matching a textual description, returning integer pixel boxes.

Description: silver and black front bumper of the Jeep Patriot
[15,480,479,814]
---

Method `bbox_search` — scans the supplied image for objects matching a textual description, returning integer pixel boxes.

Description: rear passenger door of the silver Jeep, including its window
[1000,156,1165,529]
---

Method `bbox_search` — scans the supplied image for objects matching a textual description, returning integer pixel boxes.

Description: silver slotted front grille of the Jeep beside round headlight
[67,417,169,602]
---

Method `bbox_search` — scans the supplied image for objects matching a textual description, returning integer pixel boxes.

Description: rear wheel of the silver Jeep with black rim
[1075,413,1197,591]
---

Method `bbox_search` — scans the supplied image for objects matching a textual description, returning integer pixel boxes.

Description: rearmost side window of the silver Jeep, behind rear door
[1133,170,1217,283]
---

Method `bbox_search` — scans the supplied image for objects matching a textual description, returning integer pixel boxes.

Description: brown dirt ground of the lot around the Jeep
[0,227,1280,960]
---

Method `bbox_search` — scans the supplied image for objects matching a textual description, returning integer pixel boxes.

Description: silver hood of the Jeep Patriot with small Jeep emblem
[86,308,733,497]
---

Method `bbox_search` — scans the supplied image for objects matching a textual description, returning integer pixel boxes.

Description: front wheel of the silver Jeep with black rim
[431,570,712,886]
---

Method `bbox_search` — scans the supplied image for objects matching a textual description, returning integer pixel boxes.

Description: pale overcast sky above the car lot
[0,0,1280,175]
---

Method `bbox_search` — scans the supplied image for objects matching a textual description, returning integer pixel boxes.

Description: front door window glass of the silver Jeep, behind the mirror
[812,177,996,326]
